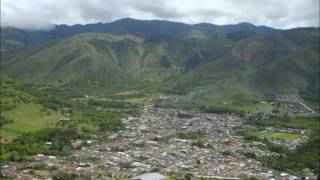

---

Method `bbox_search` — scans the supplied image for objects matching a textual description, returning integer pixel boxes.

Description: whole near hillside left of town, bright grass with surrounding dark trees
[1,76,121,165]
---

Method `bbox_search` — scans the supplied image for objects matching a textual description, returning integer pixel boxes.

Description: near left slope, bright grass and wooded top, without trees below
[0,75,62,141]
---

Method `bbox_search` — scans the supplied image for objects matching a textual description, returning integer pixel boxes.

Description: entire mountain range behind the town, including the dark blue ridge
[1,18,320,107]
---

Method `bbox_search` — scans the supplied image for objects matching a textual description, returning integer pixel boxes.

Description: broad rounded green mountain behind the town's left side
[3,33,143,94]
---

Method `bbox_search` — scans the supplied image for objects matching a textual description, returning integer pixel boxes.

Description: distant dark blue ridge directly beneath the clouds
[1,18,279,51]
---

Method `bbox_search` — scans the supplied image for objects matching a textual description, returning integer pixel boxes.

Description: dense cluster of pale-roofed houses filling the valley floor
[1,109,316,179]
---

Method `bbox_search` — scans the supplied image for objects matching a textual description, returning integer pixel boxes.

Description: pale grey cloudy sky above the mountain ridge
[1,0,319,29]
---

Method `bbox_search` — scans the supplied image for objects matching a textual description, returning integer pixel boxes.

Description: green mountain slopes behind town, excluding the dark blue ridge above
[2,27,319,104]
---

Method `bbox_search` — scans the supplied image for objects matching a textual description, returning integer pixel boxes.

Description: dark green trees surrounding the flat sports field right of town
[249,117,320,174]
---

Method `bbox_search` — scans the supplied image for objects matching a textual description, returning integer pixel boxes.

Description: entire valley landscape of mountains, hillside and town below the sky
[0,18,320,180]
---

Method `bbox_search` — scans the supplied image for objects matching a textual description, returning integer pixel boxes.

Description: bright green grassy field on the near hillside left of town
[1,103,62,140]
